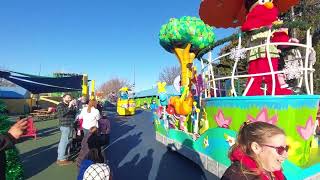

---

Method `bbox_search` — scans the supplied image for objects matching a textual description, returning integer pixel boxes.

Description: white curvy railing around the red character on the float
[200,29,315,98]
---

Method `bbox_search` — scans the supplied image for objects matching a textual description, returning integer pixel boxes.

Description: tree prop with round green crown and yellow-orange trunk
[159,16,215,86]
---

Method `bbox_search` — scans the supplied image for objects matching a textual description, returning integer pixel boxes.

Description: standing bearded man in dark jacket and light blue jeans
[57,94,77,166]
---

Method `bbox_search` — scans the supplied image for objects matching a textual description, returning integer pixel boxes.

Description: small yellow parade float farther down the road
[117,87,136,116]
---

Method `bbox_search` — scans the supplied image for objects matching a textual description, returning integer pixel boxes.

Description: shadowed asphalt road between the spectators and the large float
[105,111,218,180]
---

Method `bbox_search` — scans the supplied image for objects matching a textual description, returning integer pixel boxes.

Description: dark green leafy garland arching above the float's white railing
[197,21,312,59]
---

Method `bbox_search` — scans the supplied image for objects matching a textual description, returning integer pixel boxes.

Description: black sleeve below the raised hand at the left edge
[0,134,15,180]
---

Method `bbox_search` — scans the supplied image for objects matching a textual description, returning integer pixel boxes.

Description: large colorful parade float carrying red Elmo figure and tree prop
[153,0,320,180]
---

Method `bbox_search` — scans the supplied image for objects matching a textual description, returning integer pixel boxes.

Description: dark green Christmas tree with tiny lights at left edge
[0,101,23,180]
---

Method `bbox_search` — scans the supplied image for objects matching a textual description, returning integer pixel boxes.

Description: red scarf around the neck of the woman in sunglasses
[230,148,284,180]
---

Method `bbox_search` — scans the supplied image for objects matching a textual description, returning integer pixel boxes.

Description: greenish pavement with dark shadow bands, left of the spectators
[16,119,78,180]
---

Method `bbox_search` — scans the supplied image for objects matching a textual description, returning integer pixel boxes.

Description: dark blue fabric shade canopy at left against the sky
[0,71,83,94]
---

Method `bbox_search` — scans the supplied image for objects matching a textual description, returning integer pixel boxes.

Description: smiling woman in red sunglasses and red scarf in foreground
[221,122,289,180]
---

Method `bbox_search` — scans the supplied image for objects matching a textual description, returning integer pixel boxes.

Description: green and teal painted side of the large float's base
[157,95,320,180]
